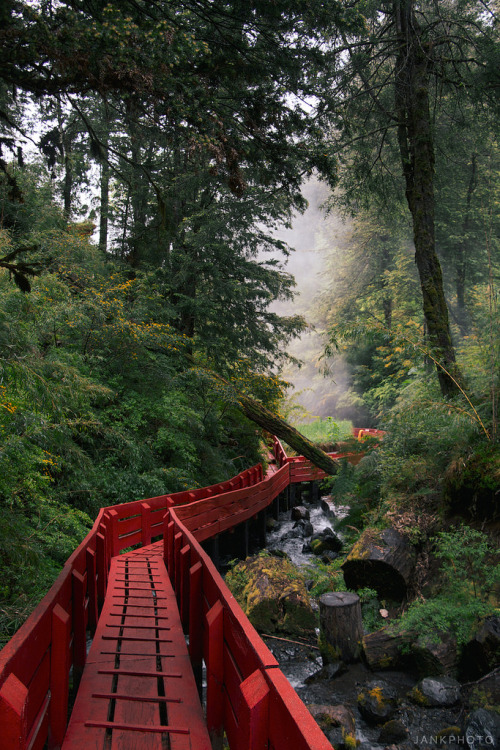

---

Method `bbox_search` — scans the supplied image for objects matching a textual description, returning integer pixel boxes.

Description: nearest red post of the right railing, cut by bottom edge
[238,669,269,750]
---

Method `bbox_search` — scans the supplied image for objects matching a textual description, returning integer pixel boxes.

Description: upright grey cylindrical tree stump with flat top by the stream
[319,591,363,663]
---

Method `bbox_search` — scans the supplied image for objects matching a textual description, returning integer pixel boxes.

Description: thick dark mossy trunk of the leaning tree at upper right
[393,0,460,397]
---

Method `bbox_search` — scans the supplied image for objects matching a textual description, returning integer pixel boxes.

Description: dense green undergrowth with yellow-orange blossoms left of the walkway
[0,172,282,643]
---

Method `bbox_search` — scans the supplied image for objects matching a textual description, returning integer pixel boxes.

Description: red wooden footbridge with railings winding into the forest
[0,430,376,750]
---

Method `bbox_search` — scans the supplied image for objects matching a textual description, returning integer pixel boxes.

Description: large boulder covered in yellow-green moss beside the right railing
[226,554,317,635]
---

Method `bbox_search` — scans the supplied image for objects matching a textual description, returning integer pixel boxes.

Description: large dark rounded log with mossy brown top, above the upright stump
[342,529,416,601]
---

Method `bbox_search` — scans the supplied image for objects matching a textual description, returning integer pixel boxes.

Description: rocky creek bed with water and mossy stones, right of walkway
[237,500,500,750]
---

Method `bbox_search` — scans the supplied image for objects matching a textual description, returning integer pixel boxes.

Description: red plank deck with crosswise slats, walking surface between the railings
[63,542,211,750]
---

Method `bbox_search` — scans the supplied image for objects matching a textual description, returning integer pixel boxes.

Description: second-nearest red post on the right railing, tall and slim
[206,599,224,750]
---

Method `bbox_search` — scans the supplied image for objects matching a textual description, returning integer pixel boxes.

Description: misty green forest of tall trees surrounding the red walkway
[0,0,500,664]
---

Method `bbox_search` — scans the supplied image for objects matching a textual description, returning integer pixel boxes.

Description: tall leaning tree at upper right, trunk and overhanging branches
[318,0,496,396]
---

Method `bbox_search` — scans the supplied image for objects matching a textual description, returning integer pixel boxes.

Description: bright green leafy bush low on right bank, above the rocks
[397,525,500,645]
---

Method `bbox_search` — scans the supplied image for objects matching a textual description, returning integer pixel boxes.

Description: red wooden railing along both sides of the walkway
[0,440,382,750]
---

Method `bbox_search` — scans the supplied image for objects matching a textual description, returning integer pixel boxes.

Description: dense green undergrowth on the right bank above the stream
[302,379,500,647]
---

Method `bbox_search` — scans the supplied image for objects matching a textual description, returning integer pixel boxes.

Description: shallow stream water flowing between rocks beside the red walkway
[264,498,463,750]
